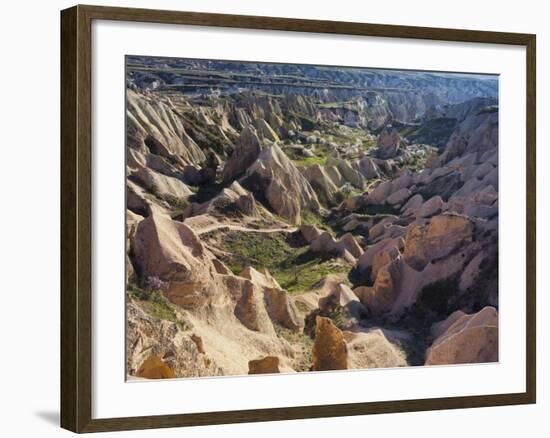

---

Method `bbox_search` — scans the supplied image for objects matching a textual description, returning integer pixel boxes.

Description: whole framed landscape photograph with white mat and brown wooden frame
[61,6,536,432]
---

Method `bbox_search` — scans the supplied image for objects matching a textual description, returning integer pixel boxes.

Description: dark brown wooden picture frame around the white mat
[61,5,536,432]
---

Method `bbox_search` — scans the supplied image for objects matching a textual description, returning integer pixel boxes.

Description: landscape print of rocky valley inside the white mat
[125,56,499,380]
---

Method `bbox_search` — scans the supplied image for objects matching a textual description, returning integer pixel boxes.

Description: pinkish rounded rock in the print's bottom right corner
[426,306,498,365]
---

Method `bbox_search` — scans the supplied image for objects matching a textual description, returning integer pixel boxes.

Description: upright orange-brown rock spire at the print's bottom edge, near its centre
[312,316,348,371]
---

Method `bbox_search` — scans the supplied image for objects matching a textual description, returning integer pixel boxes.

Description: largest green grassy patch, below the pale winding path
[215,231,349,292]
